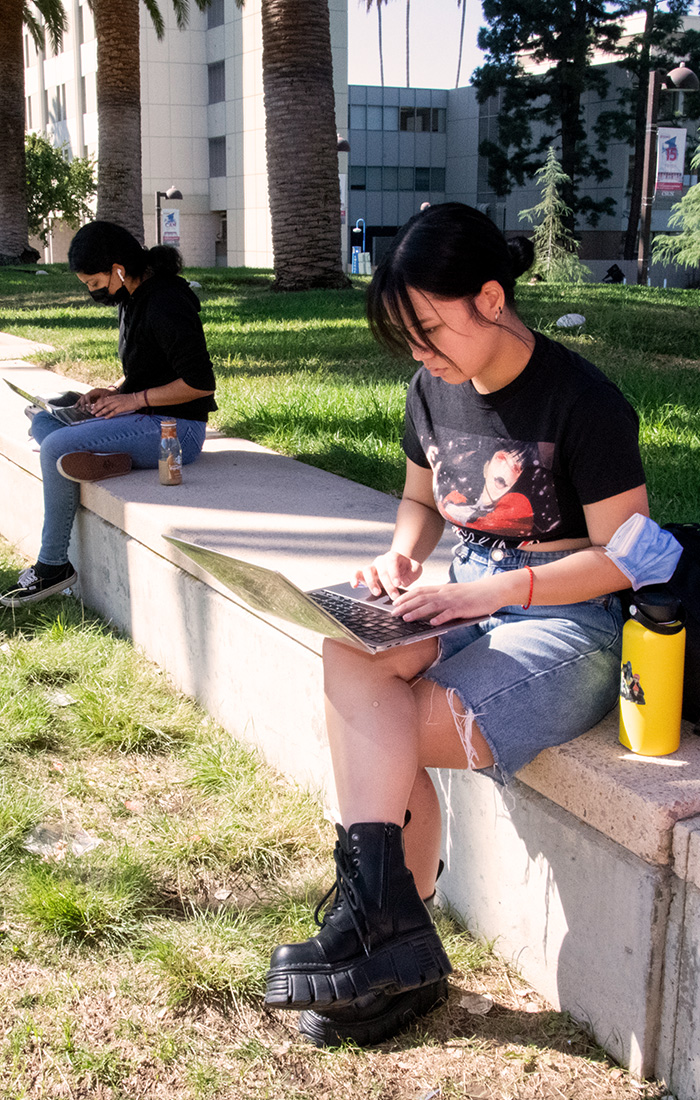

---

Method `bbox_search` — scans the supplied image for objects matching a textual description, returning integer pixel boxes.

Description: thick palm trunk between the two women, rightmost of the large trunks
[260,0,349,290]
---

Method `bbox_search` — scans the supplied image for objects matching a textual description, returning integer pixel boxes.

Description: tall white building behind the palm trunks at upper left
[24,0,348,267]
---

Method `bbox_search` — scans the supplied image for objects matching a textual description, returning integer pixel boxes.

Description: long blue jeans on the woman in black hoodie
[32,411,207,565]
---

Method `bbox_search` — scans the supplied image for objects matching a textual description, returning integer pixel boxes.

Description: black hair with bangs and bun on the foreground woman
[367,202,535,352]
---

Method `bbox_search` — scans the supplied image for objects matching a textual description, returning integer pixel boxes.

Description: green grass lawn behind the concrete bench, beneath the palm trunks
[0,265,700,523]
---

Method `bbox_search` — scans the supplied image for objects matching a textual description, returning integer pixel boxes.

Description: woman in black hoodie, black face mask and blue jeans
[0,221,217,607]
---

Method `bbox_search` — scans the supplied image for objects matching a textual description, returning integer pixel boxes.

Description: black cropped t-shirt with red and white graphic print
[403,332,644,547]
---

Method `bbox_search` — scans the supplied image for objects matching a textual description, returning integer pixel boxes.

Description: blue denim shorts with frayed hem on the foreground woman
[423,545,622,782]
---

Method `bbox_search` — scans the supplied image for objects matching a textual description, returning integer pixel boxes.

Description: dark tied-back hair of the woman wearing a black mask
[68,221,183,278]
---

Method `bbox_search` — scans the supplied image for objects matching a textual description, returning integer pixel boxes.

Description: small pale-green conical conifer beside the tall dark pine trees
[521,145,590,283]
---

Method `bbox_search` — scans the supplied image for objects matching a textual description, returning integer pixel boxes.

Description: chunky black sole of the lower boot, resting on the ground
[299,978,448,1046]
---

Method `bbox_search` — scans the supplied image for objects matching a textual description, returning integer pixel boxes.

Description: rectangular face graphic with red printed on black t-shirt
[422,435,560,540]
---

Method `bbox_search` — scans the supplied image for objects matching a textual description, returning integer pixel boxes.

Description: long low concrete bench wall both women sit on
[0,340,700,1100]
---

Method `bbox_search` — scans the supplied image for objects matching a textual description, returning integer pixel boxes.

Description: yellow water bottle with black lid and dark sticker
[620,587,686,756]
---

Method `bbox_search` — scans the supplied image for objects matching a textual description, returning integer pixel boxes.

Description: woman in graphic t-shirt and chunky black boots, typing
[266,204,648,1044]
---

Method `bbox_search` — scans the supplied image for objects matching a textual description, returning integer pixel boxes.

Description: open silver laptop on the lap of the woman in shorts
[163,535,480,653]
